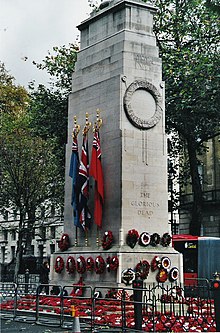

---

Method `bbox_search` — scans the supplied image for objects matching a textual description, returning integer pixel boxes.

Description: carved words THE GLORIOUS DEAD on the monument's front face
[130,191,160,218]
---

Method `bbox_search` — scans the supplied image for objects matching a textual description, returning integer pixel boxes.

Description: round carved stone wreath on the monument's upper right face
[124,80,162,129]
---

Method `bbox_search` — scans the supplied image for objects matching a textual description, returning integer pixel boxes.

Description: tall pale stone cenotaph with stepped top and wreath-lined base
[51,0,182,286]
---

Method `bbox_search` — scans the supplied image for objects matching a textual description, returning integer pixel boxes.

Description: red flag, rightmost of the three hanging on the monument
[89,131,104,228]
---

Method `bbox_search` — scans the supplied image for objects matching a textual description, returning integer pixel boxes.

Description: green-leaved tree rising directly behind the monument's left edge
[30,43,79,189]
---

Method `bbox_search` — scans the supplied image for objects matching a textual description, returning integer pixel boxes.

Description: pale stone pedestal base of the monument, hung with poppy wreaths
[50,245,183,288]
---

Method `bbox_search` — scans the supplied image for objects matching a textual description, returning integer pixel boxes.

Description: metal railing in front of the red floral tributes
[0,281,215,332]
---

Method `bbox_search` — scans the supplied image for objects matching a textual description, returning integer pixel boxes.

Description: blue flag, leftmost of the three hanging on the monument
[69,137,82,228]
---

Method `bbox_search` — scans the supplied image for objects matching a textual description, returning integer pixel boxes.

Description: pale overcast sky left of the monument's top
[0,0,98,87]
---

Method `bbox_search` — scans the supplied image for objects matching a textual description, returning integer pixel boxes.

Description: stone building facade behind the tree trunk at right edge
[179,136,220,237]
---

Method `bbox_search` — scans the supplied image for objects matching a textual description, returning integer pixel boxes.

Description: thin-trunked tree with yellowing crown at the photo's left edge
[0,67,63,281]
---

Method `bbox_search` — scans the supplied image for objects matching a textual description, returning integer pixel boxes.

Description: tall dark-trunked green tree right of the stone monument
[151,0,220,235]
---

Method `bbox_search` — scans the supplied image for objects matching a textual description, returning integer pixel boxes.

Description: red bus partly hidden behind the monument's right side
[172,234,220,286]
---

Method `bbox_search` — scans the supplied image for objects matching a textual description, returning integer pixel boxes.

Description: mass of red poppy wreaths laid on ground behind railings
[0,279,216,332]
